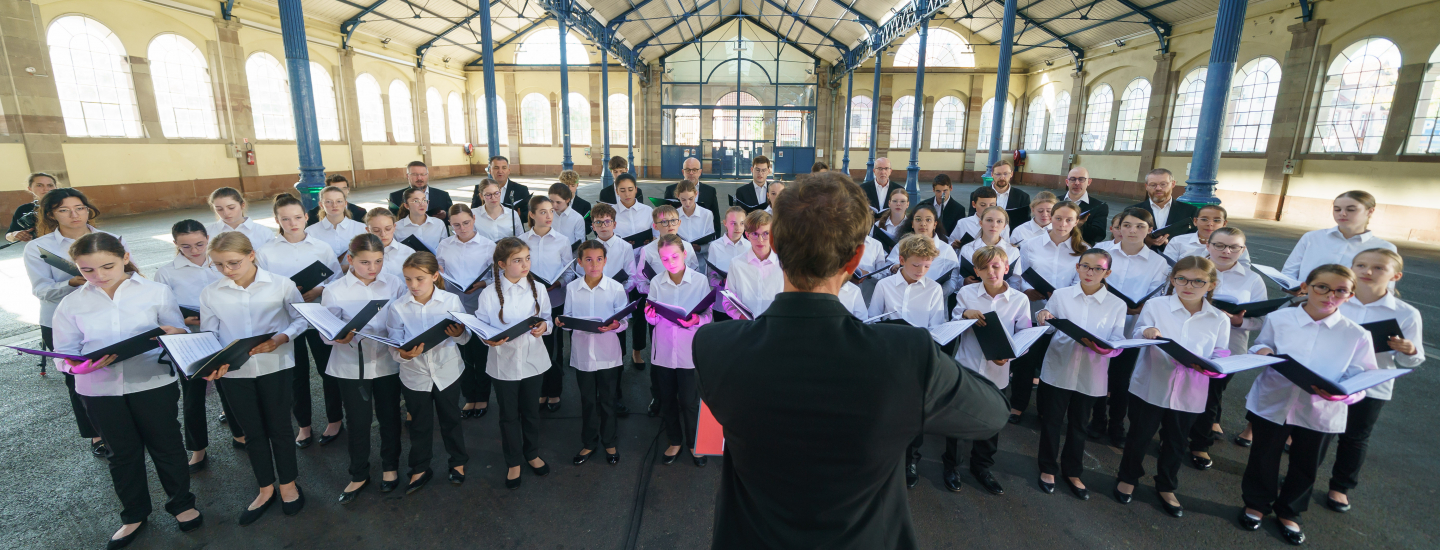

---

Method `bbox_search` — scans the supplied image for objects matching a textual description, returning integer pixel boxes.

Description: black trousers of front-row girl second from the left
[220,369,300,487]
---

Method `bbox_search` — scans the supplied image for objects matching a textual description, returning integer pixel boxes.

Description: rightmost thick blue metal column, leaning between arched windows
[1179,0,1247,204]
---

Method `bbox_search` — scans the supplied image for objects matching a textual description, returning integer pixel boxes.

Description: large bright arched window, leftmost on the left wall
[45,16,141,137]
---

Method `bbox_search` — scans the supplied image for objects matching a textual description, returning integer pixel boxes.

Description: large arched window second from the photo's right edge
[1310,37,1400,153]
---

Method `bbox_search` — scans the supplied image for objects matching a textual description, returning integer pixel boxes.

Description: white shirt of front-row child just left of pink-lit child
[564,276,629,373]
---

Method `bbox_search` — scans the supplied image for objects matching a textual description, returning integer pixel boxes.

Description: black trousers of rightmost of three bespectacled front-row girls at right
[1240,413,1333,523]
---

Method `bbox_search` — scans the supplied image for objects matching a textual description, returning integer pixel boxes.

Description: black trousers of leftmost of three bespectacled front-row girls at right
[1035,382,1096,478]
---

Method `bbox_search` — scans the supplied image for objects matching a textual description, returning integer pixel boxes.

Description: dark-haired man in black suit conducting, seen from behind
[693,173,1009,549]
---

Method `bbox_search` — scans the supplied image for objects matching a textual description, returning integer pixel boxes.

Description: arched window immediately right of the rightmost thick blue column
[1223,58,1280,153]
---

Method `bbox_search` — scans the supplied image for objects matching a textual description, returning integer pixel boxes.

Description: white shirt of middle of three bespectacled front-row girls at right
[1130,295,1230,413]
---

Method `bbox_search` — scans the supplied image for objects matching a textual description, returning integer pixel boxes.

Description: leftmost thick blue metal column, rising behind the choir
[279,0,325,210]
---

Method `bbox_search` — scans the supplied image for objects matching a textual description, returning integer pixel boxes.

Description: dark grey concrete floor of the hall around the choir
[0,177,1440,549]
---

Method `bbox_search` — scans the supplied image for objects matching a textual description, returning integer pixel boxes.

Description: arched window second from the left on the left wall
[145,35,220,140]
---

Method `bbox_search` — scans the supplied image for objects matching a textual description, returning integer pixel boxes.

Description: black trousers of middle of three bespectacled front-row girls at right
[1117,396,1200,492]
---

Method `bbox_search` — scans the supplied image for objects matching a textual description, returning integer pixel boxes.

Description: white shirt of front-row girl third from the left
[320,271,406,380]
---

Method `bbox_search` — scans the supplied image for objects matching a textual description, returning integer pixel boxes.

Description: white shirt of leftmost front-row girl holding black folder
[55,274,184,397]
